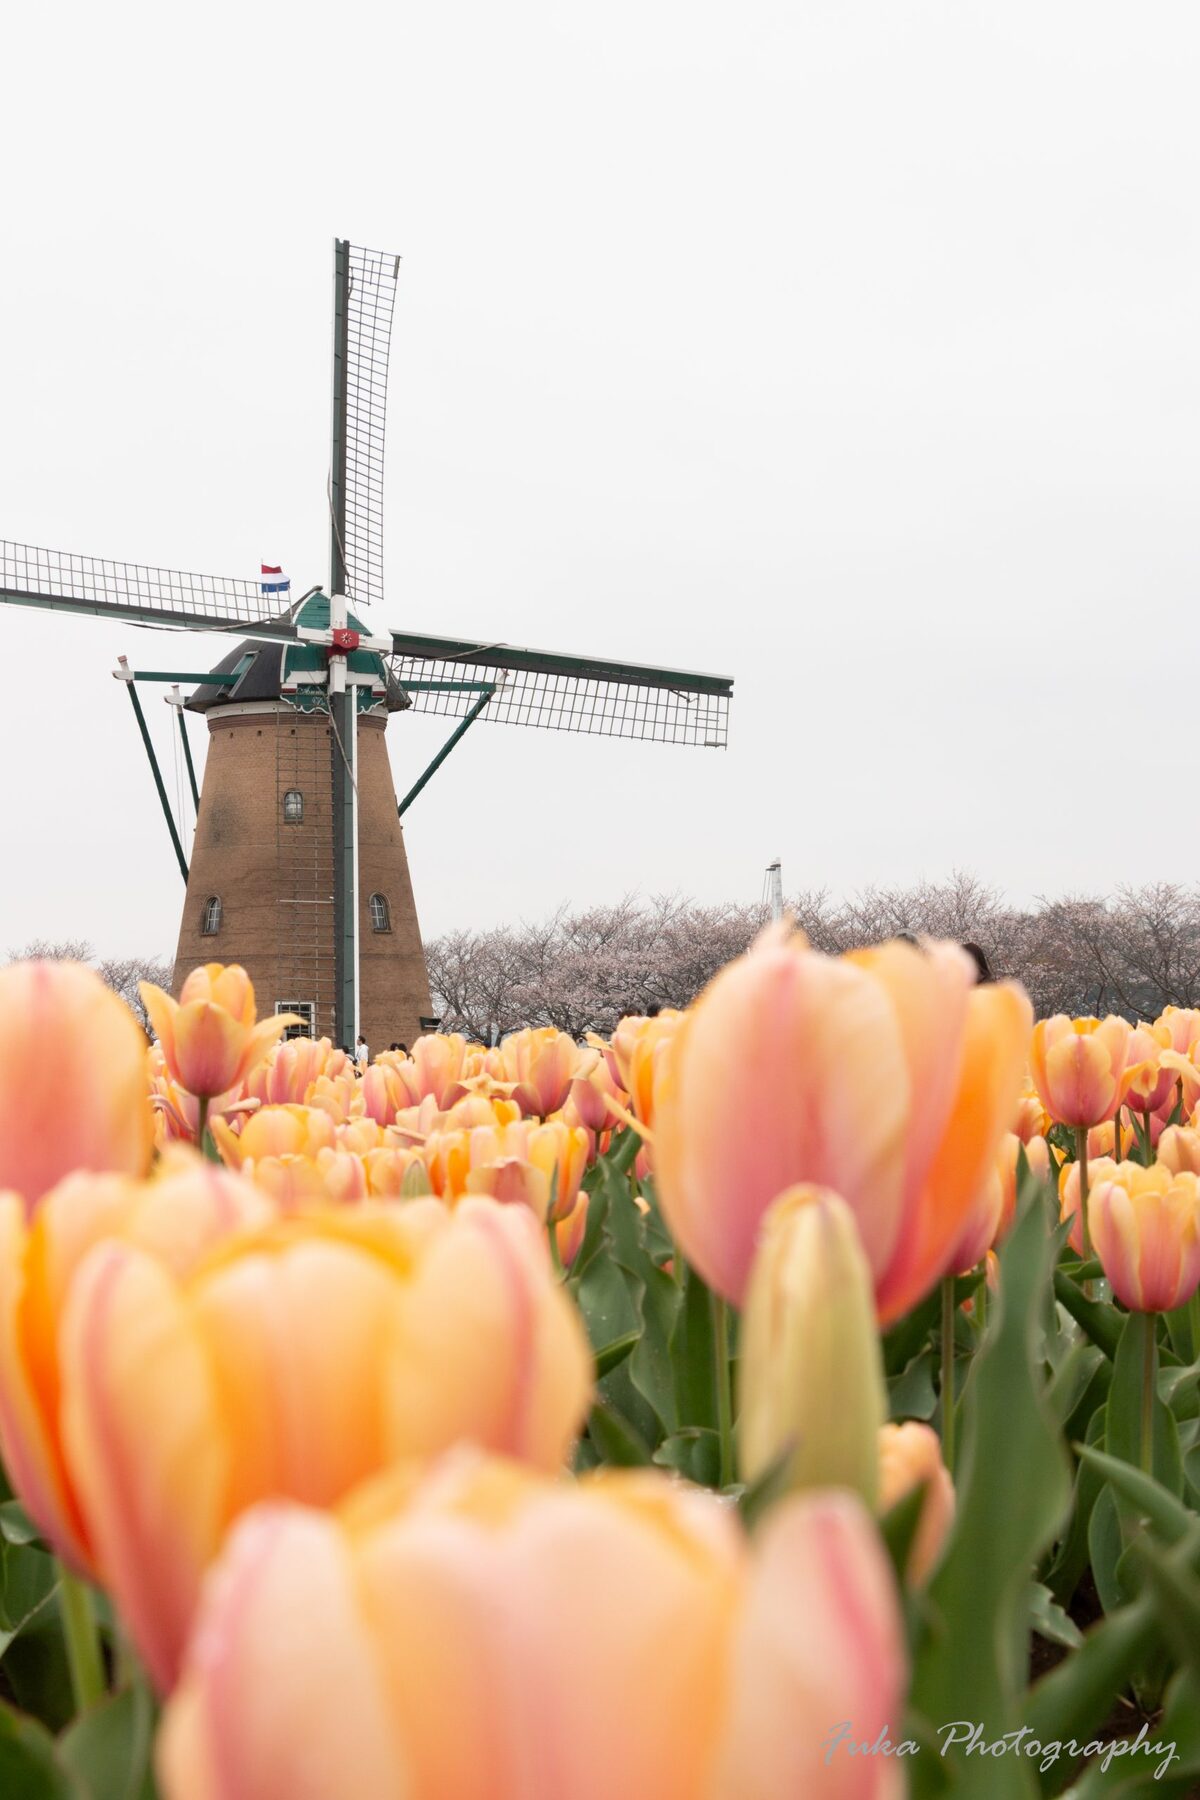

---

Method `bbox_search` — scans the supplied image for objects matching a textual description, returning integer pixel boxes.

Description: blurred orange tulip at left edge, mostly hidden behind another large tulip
[0,1147,275,1573]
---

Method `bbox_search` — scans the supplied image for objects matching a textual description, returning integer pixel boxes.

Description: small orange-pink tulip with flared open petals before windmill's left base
[139,963,300,1100]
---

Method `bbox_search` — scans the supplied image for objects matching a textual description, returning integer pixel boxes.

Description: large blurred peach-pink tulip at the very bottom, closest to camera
[158,1454,905,1800]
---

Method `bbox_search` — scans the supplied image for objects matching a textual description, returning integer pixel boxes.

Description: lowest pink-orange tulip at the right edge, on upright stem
[1087,1163,1200,1312]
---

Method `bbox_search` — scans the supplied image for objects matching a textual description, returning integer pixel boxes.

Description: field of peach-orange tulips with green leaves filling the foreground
[0,925,1200,1800]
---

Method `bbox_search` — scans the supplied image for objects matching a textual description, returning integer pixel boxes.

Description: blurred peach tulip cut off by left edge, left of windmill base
[0,963,153,1211]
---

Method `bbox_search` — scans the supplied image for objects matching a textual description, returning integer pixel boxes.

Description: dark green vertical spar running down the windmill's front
[327,238,358,1051]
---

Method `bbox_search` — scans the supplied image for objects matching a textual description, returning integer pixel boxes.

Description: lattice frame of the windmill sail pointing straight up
[342,245,399,607]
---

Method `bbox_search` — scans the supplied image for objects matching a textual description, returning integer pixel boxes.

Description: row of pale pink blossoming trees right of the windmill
[426,875,1200,1044]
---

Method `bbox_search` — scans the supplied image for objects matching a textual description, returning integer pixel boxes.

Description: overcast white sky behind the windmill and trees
[0,0,1200,952]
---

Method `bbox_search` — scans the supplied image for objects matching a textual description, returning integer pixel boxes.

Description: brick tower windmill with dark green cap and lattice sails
[0,239,732,1046]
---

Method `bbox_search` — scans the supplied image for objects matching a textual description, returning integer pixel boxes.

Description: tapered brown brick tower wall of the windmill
[173,702,430,1053]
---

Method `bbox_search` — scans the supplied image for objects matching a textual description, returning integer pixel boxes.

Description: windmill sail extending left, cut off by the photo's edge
[0,540,295,637]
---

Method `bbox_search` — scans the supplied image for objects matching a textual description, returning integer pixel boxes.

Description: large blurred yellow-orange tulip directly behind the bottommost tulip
[59,1201,590,1688]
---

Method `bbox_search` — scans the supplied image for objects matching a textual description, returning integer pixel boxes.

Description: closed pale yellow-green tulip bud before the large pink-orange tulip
[738,1188,887,1505]
